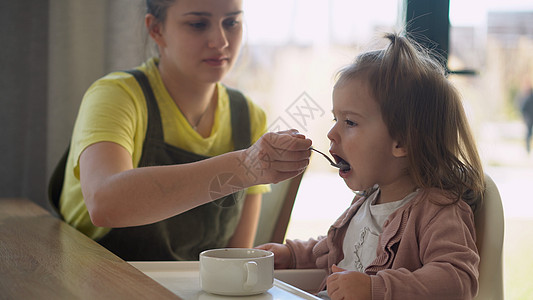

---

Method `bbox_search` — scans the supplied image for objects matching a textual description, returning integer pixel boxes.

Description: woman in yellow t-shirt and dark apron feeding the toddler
[56,0,311,260]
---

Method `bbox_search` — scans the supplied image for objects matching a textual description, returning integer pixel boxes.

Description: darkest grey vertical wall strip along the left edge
[0,0,48,206]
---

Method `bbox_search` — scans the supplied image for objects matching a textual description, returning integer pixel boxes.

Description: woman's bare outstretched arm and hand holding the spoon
[79,131,311,227]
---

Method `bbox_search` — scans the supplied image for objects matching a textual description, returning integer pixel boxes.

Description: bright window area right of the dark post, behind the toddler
[449,0,533,299]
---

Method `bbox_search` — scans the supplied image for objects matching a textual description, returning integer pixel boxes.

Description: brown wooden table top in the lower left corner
[0,199,180,299]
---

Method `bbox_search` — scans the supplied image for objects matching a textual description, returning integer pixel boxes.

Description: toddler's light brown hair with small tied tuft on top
[335,33,485,210]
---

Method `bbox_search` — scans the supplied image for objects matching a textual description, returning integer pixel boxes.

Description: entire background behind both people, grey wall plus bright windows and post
[0,0,533,299]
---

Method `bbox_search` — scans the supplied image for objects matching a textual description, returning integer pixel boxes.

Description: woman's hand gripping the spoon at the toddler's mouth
[240,129,312,185]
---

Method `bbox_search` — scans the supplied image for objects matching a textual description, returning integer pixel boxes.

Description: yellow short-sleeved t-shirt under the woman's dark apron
[60,58,270,239]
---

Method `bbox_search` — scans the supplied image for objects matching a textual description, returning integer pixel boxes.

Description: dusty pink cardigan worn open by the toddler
[286,189,479,300]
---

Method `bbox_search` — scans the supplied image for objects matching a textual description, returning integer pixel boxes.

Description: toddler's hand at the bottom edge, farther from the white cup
[327,265,372,300]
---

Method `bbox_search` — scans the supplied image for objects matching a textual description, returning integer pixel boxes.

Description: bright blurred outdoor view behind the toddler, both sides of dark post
[236,0,533,299]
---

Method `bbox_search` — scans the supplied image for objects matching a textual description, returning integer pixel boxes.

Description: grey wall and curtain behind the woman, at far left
[0,0,146,208]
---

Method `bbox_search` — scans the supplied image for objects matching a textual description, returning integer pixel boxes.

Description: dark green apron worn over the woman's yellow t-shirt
[94,70,251,261]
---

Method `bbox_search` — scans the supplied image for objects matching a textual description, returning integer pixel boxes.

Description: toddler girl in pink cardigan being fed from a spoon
[260,34,484,300]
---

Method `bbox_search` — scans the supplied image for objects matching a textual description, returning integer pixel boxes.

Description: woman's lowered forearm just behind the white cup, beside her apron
[224,194,263,248]
